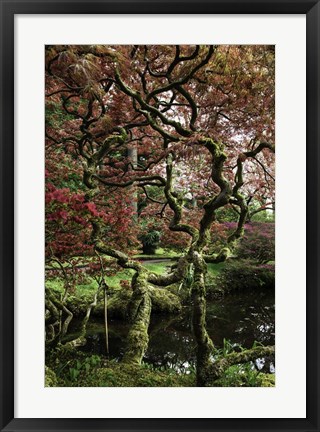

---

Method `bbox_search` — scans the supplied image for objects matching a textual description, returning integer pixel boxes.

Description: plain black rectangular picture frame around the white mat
[0,0,320,432]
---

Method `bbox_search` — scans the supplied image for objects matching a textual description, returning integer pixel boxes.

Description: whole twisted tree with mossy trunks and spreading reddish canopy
[46,45,275,386]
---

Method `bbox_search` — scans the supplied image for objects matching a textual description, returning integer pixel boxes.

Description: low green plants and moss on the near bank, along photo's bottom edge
[45,346,275,387]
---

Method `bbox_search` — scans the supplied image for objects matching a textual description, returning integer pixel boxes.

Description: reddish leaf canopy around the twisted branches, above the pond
[46,45,274,264]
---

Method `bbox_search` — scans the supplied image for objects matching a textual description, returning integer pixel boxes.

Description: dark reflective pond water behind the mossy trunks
[69,291,275,372]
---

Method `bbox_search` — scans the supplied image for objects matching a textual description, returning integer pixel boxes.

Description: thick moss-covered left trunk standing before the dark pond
[122,272,152,365]
